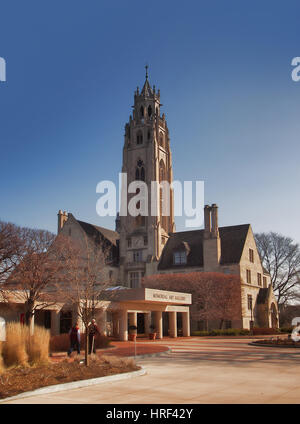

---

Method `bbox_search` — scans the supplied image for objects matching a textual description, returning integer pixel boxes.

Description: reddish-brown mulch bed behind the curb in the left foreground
[0,358,140,399]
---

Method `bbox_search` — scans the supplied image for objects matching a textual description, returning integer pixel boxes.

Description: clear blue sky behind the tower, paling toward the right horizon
[0,0,300,242]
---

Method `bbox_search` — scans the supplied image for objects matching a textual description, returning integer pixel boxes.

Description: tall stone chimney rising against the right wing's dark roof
[203,203,221,272]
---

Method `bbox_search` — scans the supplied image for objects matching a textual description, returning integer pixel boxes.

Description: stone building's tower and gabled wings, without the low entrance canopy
[52,72,278,329]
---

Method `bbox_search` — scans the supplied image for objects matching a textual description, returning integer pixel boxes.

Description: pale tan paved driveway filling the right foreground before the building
[2,337,300,404]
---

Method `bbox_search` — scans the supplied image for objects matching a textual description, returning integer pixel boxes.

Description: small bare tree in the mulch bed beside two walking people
[56,235,112,366]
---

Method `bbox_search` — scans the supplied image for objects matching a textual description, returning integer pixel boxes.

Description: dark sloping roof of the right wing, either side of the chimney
[158,224,250,270]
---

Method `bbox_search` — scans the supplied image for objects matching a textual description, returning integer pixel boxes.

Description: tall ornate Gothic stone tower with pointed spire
[119,66,175,287]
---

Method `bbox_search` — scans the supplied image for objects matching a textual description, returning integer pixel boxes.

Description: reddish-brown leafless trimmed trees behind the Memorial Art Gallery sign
[143,272,241,329]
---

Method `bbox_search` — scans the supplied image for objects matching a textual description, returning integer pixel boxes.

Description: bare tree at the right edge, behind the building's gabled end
[255,232,300,307]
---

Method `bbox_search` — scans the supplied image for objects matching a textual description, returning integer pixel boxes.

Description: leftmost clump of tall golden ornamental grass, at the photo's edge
[2,322,28,366]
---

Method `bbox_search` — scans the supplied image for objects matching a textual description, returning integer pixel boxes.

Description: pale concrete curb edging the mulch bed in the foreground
[0,366,146,404]
